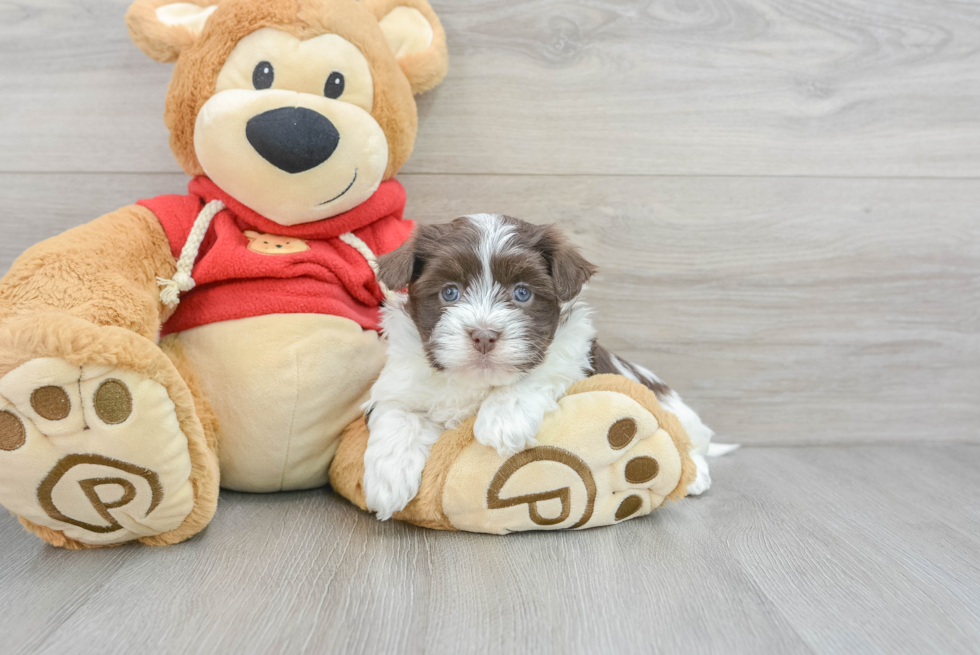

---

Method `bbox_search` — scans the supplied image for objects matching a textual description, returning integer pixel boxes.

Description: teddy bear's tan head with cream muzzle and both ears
[126,0,448,225]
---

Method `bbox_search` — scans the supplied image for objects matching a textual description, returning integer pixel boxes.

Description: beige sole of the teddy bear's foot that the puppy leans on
[442,391,681,534]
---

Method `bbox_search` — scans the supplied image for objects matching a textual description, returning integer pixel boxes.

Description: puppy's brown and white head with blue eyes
[378,214,596,384]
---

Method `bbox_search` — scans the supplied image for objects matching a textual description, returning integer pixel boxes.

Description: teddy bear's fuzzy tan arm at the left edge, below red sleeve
[0,205,176,341]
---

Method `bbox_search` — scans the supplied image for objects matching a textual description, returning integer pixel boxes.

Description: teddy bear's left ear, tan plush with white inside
[126,0,219,62]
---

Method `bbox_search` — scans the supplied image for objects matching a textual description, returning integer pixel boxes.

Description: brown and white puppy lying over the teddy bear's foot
[364,214,712,520]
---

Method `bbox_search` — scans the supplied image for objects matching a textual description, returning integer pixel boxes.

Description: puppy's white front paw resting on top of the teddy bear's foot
[473,384,558,457]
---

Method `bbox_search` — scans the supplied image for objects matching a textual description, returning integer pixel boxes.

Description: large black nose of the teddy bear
[245,107,340,174]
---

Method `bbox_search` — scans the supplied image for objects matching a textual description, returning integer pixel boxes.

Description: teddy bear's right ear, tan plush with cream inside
[364,0,449,95]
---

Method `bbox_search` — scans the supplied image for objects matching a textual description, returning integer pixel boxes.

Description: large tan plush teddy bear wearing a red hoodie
[0,0,694,549]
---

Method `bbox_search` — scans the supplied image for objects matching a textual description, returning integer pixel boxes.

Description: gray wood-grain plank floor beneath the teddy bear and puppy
[0,444,980,655]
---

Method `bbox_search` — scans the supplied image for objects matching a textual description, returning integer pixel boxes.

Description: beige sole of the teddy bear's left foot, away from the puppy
[0,358,194,545]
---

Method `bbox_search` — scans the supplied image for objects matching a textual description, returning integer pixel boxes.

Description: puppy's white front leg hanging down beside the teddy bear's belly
[364,403,442,521]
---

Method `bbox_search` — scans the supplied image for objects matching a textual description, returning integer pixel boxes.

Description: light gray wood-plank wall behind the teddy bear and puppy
[0,0,980,444]
